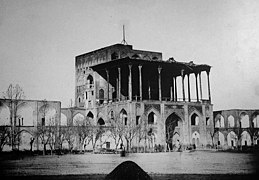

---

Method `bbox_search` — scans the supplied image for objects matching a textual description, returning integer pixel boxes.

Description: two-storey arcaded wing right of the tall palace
[213,109,259,149]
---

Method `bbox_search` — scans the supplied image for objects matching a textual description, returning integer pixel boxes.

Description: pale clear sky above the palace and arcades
[0,0,259,110]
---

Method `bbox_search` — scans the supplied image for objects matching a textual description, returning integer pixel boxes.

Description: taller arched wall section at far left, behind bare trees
[0,99,61,151]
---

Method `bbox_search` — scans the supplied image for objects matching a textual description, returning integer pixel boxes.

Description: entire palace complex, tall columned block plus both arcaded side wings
[0,44,259,151]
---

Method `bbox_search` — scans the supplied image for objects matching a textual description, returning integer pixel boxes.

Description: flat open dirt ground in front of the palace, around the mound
[0,151,258,180]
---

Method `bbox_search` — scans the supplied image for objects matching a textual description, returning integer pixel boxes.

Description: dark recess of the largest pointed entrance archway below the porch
[165,113,181,150]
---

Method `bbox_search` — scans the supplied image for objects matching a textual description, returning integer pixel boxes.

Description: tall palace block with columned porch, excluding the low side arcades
[72,44,214,150]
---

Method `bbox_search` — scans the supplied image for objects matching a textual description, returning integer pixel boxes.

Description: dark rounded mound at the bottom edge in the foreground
[105,161,152,180]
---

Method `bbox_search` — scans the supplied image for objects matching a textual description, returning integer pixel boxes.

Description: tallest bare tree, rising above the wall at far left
[3,84,25,150]
